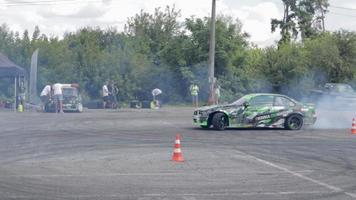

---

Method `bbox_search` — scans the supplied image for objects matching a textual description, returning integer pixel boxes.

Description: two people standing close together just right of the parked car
[102,81,119,109]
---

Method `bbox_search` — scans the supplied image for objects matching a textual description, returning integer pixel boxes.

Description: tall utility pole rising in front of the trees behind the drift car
[208,0,216,105]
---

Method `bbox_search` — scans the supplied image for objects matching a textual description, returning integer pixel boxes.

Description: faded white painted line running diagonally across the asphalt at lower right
[235,149,356,199]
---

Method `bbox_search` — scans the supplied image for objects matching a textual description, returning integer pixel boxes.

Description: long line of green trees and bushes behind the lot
[0,0,356,103]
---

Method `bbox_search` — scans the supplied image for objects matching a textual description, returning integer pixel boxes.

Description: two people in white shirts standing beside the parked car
[40,83,63,113]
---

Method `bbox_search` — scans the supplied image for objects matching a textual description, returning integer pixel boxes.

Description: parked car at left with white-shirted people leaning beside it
[45,84,83,112]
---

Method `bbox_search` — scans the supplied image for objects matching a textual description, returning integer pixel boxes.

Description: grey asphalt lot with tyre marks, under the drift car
[0,107,356,200]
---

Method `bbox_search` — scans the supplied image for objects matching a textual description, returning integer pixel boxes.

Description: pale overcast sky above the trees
[0,0,356,46]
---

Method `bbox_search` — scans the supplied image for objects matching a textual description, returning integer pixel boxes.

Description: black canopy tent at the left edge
[0,53,26,110]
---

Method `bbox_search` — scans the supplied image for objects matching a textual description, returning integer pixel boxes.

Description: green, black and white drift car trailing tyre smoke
[193,93,316,130]
